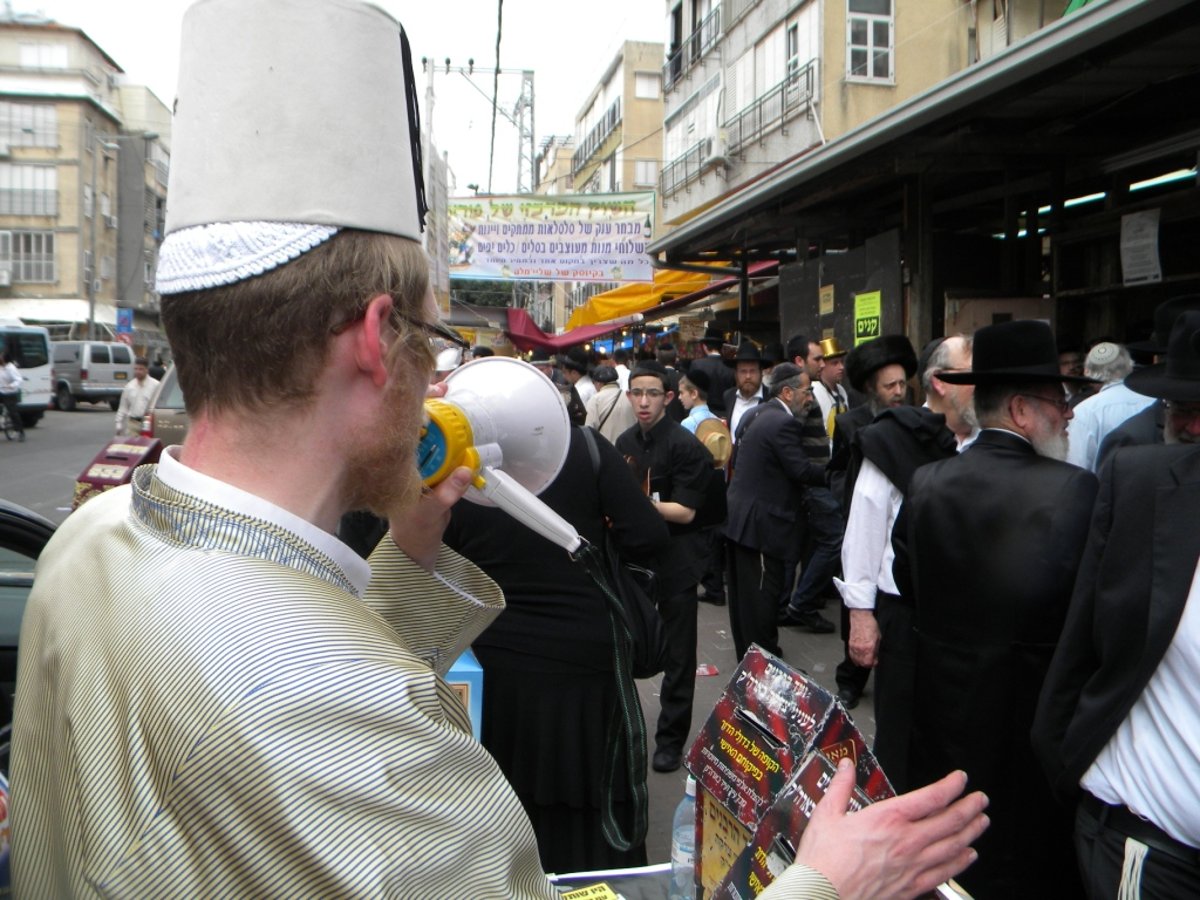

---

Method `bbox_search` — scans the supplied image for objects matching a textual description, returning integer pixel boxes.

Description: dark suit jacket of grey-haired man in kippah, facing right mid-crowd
[725,400,824,559]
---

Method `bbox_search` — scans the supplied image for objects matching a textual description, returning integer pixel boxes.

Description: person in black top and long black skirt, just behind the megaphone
[445,428,668,872]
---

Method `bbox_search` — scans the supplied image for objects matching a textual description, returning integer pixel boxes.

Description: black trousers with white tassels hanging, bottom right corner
[1075,798,1200,900]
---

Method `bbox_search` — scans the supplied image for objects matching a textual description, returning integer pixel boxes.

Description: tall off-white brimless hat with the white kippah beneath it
[158,0,426,294]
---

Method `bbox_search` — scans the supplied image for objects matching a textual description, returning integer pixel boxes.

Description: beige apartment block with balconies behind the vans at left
[0,14,170,352]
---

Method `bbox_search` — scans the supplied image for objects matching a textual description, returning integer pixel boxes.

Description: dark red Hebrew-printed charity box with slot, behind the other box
[685,646,895,898]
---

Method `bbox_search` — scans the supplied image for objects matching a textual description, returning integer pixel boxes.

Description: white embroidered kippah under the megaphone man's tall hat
[156,222,337,294]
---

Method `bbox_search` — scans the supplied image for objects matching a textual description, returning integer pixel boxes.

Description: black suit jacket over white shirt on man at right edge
[1033,445,1200,796]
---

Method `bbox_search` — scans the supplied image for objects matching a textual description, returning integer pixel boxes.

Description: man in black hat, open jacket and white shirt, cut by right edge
[1033,311,1200,898]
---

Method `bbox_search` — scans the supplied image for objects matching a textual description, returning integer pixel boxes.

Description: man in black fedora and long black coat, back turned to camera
[893,320,1097,898]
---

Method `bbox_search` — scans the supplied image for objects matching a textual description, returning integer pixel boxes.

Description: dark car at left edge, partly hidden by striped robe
[0,500,55,725]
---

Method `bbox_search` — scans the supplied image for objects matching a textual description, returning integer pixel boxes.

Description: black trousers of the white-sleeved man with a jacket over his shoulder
[872,600,918,793]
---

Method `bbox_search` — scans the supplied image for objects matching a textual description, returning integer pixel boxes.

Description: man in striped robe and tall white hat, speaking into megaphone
[10,0,983,900]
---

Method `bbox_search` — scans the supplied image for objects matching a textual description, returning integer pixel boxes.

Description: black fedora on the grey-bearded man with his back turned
[937,319,1097,384]
